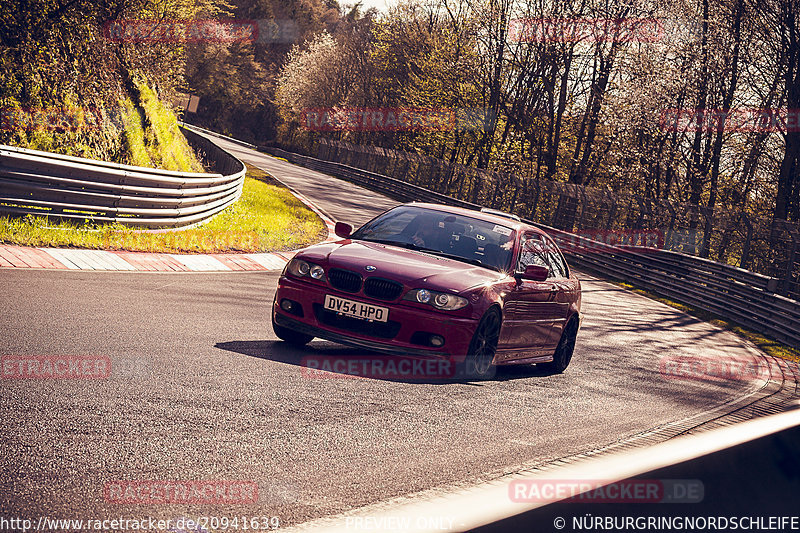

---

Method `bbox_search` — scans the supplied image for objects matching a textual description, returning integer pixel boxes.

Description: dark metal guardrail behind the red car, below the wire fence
[267,148,800,347]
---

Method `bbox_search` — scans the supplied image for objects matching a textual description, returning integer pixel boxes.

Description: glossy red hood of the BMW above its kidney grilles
[297,240,506,292]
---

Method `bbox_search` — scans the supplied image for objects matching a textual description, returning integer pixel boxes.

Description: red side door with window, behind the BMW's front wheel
[504,233,566,359]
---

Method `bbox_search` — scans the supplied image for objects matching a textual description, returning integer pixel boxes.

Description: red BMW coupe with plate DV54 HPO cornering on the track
[272,203,581,378]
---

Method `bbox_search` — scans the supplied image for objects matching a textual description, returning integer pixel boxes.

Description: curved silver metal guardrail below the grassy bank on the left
[0,125,245,227]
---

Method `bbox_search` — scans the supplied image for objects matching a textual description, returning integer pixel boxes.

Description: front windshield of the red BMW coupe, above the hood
[352,206,514,271]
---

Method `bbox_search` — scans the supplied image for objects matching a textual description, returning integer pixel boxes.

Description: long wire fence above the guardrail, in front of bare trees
[310,139,800,299]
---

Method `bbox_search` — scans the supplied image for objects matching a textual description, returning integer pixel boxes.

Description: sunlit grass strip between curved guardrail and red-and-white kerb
[0,166,326,253]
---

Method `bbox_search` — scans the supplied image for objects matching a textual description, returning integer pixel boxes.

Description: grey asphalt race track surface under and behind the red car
[0,136,776,524]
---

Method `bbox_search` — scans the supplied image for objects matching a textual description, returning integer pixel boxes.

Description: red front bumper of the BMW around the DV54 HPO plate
[272,277,477,358]
